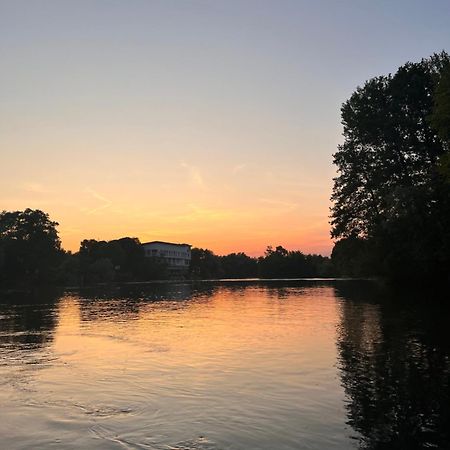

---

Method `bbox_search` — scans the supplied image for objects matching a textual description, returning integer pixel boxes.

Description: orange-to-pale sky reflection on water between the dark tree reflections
[0,283,356,449]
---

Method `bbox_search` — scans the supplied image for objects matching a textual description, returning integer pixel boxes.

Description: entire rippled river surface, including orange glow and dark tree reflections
[0,281,450,450]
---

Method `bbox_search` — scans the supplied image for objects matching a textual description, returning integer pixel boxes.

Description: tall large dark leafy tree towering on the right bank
[331,52,450,276]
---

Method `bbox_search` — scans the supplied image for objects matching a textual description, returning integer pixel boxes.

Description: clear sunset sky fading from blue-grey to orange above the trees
[0,0,450,256]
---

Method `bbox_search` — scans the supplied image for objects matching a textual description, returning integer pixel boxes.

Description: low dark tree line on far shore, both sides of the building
[0,209,333,286]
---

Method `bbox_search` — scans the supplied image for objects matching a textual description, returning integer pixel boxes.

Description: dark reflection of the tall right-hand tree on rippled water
[336,284,450,449]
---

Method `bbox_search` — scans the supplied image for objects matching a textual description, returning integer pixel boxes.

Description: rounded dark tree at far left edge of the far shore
[0,209,63,284]
